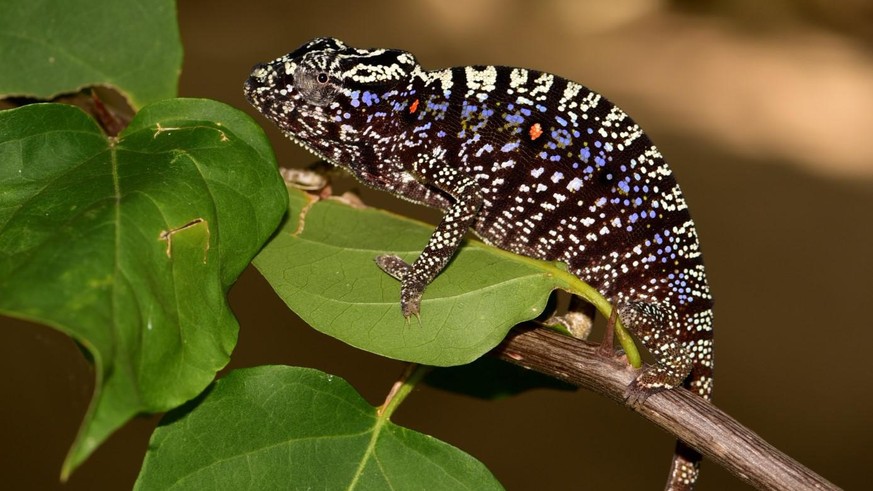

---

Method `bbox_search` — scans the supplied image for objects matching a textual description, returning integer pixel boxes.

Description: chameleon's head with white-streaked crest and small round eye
[244,38,420,165]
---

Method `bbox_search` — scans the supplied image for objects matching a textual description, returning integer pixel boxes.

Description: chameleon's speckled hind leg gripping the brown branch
[613,302,693,405]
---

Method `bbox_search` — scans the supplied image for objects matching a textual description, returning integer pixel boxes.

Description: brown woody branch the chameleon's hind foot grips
[492,324,839,490]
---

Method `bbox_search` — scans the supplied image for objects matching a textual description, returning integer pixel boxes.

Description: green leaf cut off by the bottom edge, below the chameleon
[135,366,500,490]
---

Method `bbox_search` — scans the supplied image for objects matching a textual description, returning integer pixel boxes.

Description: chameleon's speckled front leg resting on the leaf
[376,149,482,318]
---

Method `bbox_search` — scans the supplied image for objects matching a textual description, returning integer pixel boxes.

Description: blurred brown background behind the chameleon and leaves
[0,0,873,490]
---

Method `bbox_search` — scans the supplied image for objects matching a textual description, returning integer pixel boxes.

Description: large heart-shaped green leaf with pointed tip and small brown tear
[0,99,287,476]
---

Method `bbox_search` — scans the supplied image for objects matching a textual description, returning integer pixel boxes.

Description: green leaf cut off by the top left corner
[0,0,182,109]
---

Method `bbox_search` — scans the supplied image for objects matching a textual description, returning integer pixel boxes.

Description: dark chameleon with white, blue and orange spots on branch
[244,37,713,489]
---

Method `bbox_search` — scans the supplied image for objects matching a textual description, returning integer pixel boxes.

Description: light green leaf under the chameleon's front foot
[254,190,633,366]
